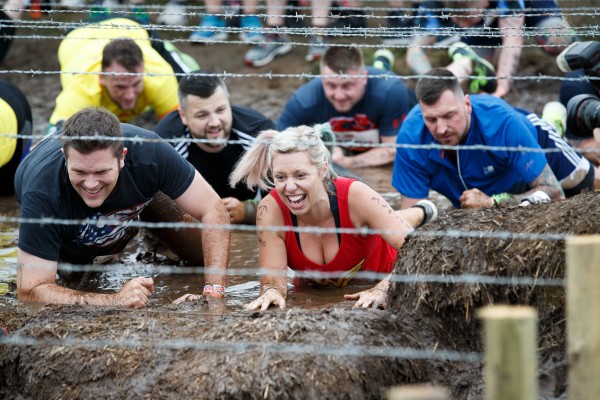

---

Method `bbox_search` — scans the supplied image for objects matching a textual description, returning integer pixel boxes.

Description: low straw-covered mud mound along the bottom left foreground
[0,304,432,399]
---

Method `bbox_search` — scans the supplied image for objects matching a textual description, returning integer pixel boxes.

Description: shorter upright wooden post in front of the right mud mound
[478,306,538,400]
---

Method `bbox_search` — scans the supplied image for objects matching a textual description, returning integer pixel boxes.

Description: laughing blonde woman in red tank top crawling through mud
[230,124,437,311]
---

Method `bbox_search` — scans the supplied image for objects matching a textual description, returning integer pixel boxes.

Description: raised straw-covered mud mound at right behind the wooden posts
[387,192,600,399]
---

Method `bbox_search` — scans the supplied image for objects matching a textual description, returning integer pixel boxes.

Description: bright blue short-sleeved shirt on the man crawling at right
[392,95,547,208]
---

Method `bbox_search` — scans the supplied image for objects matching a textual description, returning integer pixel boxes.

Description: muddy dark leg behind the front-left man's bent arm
[140,192,204,265]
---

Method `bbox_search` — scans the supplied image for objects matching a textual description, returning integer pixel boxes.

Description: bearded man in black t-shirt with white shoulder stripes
[155,71,275,224]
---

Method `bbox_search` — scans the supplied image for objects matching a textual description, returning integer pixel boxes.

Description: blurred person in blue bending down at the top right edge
[406,0,574,97]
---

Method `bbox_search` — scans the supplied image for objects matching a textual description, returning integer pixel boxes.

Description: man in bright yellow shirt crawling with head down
[48,18,198,133]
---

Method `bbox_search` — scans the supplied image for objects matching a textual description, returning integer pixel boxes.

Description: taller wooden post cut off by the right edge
[566,235,600,400]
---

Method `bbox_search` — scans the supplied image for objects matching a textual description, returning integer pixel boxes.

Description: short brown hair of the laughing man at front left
[61,107,125,158]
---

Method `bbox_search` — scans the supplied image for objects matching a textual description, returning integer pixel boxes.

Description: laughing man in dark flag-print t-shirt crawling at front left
[15,108,230,308]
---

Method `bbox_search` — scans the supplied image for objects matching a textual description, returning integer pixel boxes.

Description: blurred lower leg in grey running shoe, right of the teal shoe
[244,0,292,67]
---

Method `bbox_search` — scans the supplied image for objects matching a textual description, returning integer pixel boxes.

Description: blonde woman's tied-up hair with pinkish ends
[229,124,337,191]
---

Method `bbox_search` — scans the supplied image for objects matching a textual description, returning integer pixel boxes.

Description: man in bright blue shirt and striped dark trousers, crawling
[392,68,595,208]
